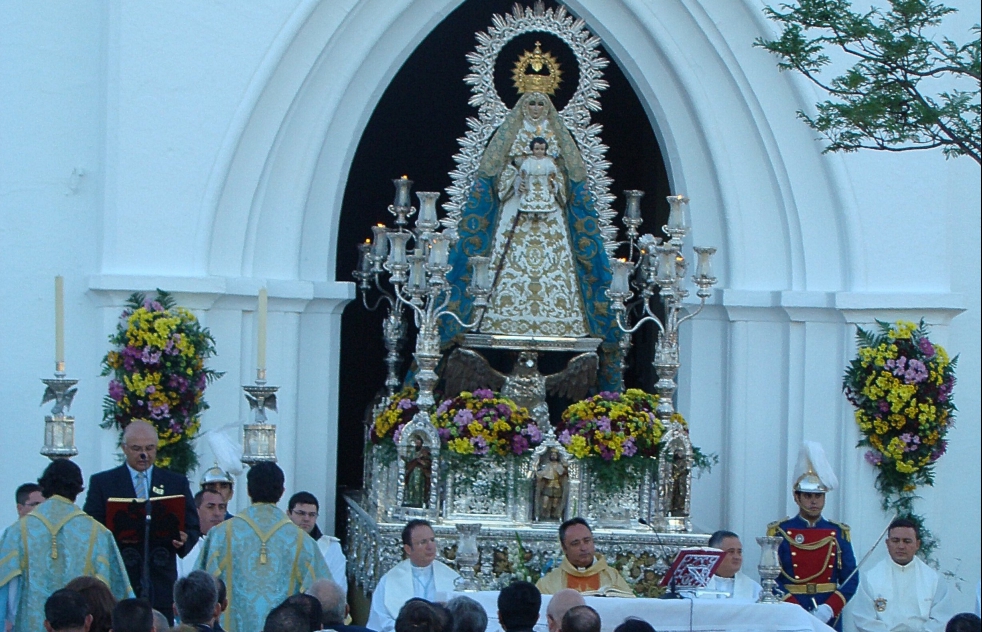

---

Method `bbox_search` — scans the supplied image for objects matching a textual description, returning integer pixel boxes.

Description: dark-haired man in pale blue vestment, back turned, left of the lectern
[0,459,133,631]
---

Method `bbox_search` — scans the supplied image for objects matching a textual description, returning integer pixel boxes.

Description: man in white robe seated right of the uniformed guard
[851,518,954,632]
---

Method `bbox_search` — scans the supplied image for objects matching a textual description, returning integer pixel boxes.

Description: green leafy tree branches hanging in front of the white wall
[755,0,982,162]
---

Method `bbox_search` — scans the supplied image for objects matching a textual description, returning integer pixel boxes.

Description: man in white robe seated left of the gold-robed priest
[365,520,460,632]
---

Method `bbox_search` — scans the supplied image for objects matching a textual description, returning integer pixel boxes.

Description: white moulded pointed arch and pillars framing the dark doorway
[92,0,972,588]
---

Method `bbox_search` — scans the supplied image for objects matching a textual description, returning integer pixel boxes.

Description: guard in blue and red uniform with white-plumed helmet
[767,441,859,630]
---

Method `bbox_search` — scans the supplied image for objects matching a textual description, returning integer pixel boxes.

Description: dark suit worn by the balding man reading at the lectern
[83,464,201,616]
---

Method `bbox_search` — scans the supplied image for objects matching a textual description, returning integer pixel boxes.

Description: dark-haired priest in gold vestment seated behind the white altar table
[536,518,634,597]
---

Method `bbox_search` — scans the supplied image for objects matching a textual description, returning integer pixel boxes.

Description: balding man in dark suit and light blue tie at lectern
[84,420,201,623]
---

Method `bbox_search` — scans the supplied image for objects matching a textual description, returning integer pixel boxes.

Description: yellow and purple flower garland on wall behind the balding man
[101,290,223,474]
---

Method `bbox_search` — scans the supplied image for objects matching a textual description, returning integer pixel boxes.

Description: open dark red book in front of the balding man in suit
[106,495,185,546]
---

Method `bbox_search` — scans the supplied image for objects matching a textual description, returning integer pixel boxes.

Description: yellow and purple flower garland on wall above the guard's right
[842,320,958,552]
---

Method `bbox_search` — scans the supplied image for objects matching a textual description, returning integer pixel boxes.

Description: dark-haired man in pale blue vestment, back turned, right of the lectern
[198,463,333,632]
